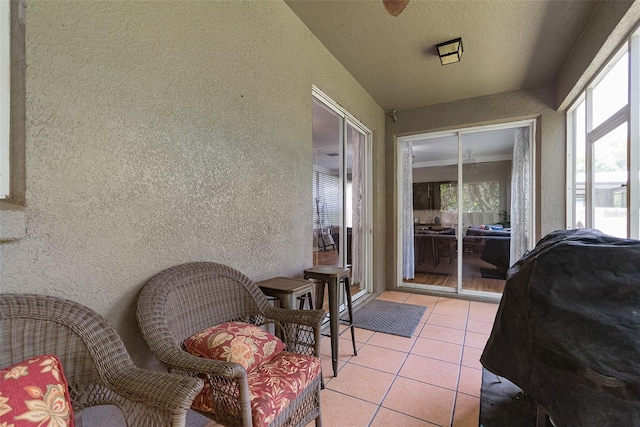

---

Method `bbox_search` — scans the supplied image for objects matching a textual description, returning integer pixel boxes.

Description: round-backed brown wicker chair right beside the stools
[137,262,325,427]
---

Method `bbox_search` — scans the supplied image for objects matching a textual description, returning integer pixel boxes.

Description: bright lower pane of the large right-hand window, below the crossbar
[593,122,628,238]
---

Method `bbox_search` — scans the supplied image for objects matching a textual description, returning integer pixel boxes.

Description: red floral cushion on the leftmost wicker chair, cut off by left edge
[0,354,74,427]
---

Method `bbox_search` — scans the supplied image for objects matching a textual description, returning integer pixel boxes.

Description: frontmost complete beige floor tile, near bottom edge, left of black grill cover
[382,377,455,426]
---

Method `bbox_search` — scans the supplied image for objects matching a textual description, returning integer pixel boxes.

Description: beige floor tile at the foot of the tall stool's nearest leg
[326,363,394,404]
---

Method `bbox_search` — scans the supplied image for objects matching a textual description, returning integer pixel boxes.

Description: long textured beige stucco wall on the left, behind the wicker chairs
[0,1,385,366]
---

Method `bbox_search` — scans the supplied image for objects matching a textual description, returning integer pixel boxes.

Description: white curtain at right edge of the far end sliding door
[510,127,531,265]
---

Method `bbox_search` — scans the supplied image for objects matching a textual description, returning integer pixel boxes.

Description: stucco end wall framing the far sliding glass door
[386,86,566,289]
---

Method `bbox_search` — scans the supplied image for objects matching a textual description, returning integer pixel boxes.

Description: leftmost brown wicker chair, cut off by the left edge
[0,294,203,427]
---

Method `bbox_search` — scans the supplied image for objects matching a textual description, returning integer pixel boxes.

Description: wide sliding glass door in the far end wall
[398,122,533,295]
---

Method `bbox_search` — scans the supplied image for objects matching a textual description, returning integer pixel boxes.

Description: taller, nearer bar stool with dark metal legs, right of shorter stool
[304,265,358,377]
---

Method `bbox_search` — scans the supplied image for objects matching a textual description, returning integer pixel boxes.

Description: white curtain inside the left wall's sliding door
[344,128,365,283]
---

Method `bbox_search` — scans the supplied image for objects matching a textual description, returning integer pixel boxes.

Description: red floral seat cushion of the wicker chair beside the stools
[191,351,320,427]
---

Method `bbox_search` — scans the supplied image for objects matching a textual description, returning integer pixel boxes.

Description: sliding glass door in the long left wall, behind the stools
[312,90,371,306]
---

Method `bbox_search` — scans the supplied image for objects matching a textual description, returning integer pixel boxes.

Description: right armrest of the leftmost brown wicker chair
[109,366,203,413]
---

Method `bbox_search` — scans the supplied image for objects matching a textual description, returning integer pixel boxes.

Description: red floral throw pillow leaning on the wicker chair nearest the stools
[184,322,285,372]
